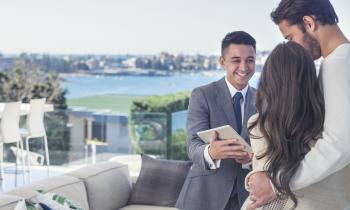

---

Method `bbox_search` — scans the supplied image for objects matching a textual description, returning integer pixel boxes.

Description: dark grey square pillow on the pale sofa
[128,155,191,207]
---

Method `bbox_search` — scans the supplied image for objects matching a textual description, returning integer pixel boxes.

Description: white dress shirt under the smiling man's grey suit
[204,77,250,169]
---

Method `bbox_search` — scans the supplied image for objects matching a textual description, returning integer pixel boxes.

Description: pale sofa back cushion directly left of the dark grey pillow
[69,162,131,210]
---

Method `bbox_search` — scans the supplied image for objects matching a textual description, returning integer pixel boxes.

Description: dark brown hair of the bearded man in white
[271,0,339,28]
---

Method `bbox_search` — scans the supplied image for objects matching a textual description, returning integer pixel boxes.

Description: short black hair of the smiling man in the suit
[221,31,256,55]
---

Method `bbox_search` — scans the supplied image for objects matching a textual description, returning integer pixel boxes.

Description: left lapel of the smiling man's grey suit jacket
[216,77,237,129]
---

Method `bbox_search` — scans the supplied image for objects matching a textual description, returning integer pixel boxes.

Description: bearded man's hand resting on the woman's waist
[247,172,276,210]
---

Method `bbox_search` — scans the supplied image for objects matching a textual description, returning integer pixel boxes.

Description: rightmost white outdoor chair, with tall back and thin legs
[22,98,50,176]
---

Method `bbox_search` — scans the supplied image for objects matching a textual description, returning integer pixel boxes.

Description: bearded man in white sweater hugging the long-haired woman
[248,0,350,209]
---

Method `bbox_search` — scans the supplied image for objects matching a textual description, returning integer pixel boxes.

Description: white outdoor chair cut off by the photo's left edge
[0,102,25,183]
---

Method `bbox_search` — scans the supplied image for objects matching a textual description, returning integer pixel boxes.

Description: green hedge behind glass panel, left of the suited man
[129,92,190,159]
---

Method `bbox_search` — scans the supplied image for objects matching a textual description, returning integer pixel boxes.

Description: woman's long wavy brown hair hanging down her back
[248,42,325,208]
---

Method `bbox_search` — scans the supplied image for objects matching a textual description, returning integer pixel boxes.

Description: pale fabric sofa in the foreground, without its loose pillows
[0,162,176,210]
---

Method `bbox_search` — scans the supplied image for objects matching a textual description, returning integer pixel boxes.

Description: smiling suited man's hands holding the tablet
[208,132,251,164]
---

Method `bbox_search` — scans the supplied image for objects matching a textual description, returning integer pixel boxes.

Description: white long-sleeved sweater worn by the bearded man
[290,43,350,190]
